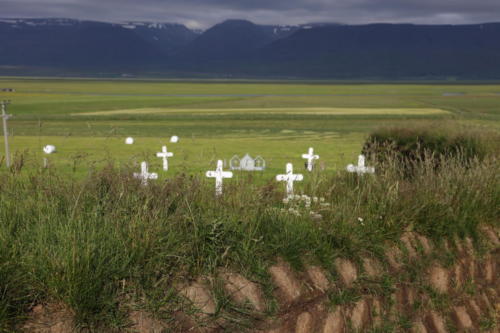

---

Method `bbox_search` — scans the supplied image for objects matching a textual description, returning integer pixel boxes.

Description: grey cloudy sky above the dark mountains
[0,0,500,29]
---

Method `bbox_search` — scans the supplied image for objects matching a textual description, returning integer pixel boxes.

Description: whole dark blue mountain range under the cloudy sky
[0,19,500,79]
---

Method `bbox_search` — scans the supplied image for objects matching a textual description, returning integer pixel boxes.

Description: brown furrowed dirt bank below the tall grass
[23,227,500,333]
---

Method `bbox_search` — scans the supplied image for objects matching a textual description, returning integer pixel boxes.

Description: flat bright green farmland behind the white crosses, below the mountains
[0,78,500,178]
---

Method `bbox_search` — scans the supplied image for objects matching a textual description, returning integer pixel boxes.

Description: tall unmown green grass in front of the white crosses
[0,147,500,331]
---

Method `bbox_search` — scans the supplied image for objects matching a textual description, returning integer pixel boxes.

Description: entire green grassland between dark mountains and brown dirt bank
[0,78,500,332]
